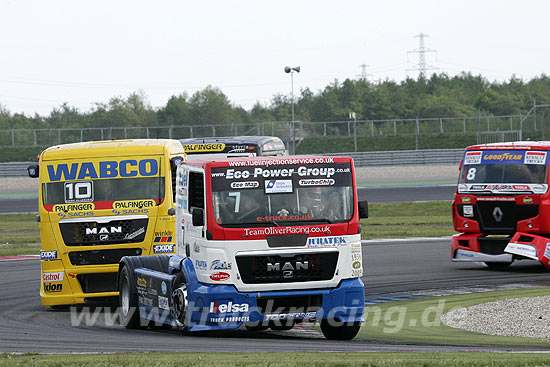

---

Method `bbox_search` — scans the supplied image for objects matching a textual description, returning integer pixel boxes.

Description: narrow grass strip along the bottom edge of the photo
[0,352,550,367]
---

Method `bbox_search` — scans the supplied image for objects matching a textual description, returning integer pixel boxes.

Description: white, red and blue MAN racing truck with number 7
[118,156,368,340]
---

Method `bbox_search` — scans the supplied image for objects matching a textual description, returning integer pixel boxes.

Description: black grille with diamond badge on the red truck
[458,201,539,233]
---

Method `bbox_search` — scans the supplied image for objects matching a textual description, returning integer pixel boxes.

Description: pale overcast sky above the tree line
[0,0,550,115]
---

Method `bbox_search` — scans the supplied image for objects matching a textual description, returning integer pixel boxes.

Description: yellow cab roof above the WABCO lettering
[40,139,185,161]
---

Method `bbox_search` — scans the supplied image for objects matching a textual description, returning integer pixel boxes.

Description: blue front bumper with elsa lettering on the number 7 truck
[184,278,365,331]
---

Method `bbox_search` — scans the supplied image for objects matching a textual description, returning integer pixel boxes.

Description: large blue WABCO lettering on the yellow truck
[47,159,159,182]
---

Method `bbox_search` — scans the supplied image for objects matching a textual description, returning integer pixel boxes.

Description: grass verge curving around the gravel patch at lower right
[358,287,550,348]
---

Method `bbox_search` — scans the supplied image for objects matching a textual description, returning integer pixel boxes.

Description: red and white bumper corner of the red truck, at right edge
[504,232,550,269]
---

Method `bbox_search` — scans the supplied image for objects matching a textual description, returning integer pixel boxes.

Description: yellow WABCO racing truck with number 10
[28,139,186,306]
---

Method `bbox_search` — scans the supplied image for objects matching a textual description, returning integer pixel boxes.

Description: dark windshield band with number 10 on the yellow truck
[42,177,164,205]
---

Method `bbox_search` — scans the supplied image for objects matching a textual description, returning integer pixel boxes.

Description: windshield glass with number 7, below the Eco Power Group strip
[213,186,353,227]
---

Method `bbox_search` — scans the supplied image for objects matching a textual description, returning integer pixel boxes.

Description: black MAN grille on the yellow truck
[59,218,149,246]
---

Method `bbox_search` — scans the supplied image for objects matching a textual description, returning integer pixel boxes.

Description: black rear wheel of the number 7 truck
[118,266,140,329]
